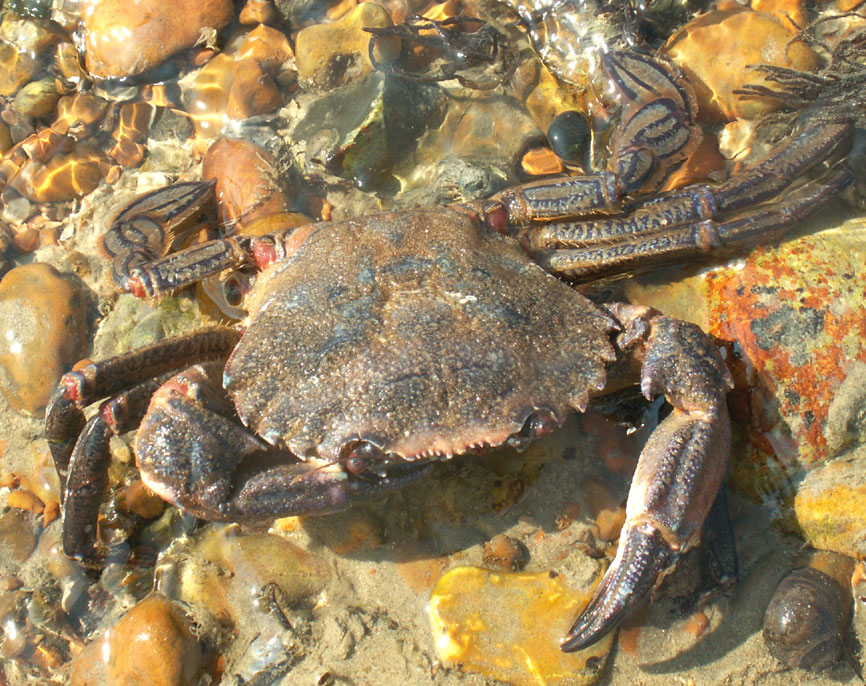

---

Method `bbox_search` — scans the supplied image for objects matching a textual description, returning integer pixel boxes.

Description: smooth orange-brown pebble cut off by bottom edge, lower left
[103,595,203,686]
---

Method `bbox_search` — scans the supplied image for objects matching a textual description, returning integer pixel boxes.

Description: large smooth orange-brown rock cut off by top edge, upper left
[82,0,234,79]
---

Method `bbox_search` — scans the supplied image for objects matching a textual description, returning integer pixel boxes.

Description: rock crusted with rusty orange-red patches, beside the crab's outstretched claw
[626,220,866,502]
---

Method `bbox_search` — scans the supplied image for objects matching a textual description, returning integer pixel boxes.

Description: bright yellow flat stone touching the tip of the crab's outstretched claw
[430,567,613,686]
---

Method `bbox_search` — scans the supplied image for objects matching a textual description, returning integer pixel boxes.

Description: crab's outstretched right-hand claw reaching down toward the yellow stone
[562,305,733,651]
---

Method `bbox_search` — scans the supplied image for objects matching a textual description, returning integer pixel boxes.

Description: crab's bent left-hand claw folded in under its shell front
[135,365,429,521]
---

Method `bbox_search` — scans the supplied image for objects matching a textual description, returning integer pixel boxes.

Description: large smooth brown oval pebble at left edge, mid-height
[0,262,86,415]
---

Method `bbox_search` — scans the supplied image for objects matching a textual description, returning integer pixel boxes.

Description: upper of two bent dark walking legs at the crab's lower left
[45,327,240,481]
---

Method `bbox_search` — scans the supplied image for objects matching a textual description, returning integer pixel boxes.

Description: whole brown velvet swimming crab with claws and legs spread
[46,52,854,650]
